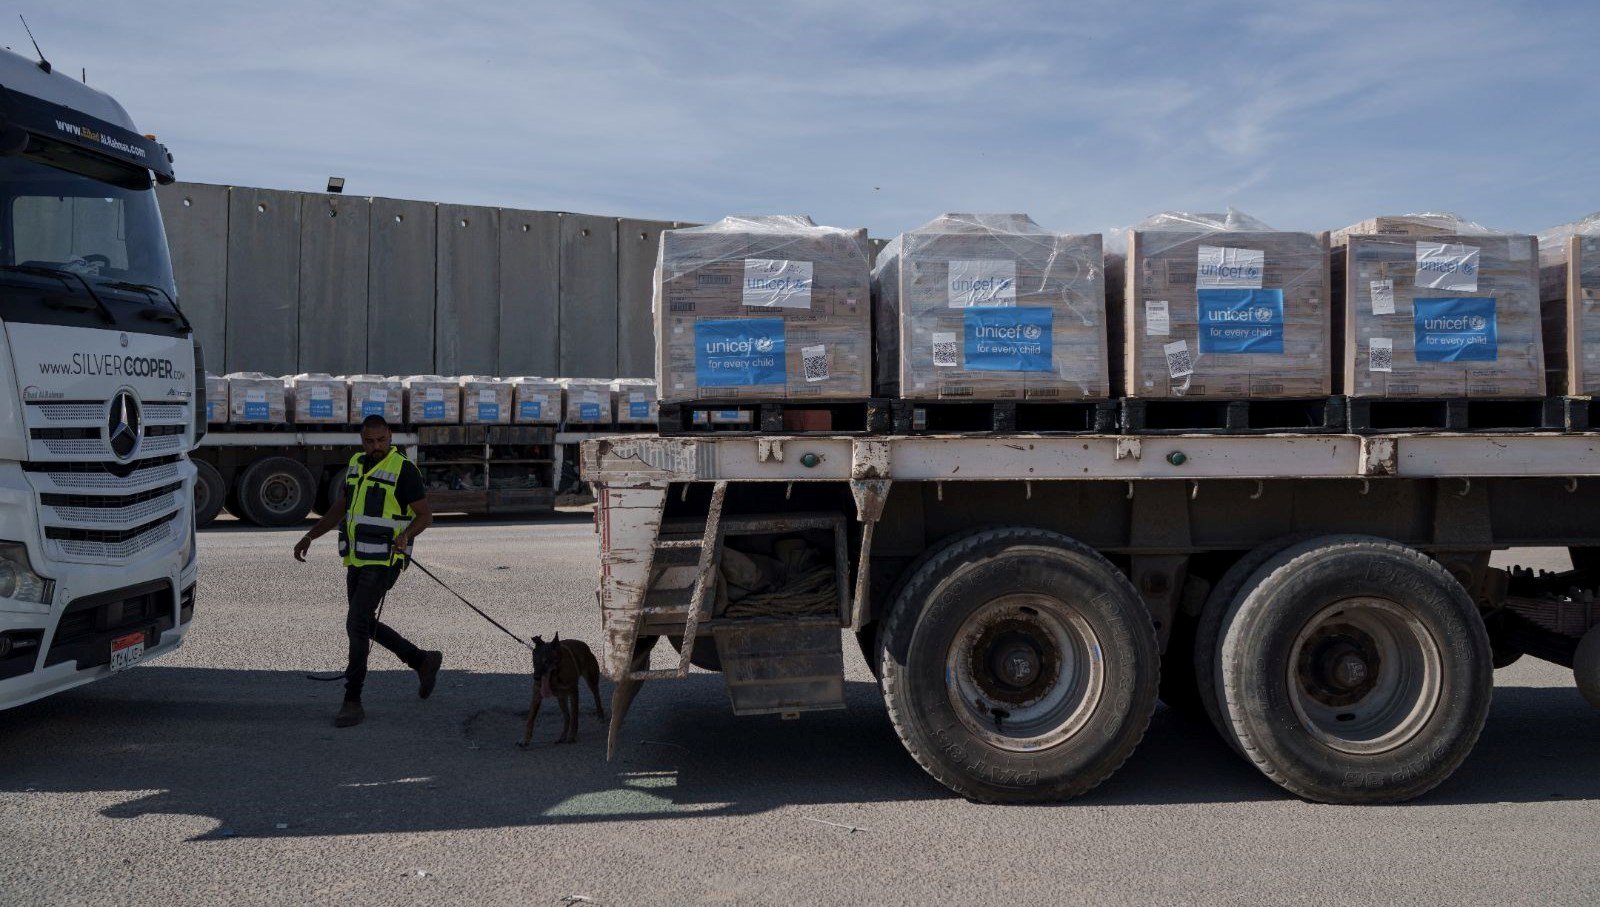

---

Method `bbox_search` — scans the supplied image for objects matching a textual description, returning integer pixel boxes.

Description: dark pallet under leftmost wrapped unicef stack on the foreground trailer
[656,397,890,435]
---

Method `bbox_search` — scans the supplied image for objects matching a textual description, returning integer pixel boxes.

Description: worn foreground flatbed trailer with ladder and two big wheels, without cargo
[581,432,1600,803]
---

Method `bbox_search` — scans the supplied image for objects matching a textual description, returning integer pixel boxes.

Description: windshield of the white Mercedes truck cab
[0,139,178,302]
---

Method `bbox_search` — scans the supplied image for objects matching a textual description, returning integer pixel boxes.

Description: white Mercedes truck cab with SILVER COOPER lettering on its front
[0,51,205,709]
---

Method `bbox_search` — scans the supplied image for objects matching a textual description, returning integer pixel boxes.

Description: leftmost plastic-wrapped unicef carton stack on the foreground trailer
[656,216,872,406]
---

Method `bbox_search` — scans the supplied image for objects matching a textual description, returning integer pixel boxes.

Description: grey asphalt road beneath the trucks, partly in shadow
[0,517,1600,907]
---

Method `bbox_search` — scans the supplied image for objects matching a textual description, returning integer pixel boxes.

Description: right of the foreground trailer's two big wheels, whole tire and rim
[1221,536,1493,803]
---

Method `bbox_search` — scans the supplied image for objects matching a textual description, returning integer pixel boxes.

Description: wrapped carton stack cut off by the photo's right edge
[1539,214,1600,397]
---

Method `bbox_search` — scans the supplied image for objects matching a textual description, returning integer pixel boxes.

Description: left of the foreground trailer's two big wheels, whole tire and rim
[877,528,1160,803]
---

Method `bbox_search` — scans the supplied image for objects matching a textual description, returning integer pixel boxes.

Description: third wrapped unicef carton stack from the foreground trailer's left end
[1114,210,1333,400]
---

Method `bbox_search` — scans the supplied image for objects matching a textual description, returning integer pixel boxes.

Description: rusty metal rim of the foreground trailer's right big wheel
[1288,598,1442,755]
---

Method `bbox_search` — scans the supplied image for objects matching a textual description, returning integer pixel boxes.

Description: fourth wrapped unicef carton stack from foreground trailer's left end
[1333,214,1544,398]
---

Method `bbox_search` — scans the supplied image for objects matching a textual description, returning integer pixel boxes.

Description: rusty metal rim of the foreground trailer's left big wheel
[944,593,1106,752]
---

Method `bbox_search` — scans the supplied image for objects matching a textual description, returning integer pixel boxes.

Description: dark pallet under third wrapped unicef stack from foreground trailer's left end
[1122,397,1346,435]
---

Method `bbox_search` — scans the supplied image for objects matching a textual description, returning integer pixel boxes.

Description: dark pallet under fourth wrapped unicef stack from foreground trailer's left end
[1349,397,1568,435]
